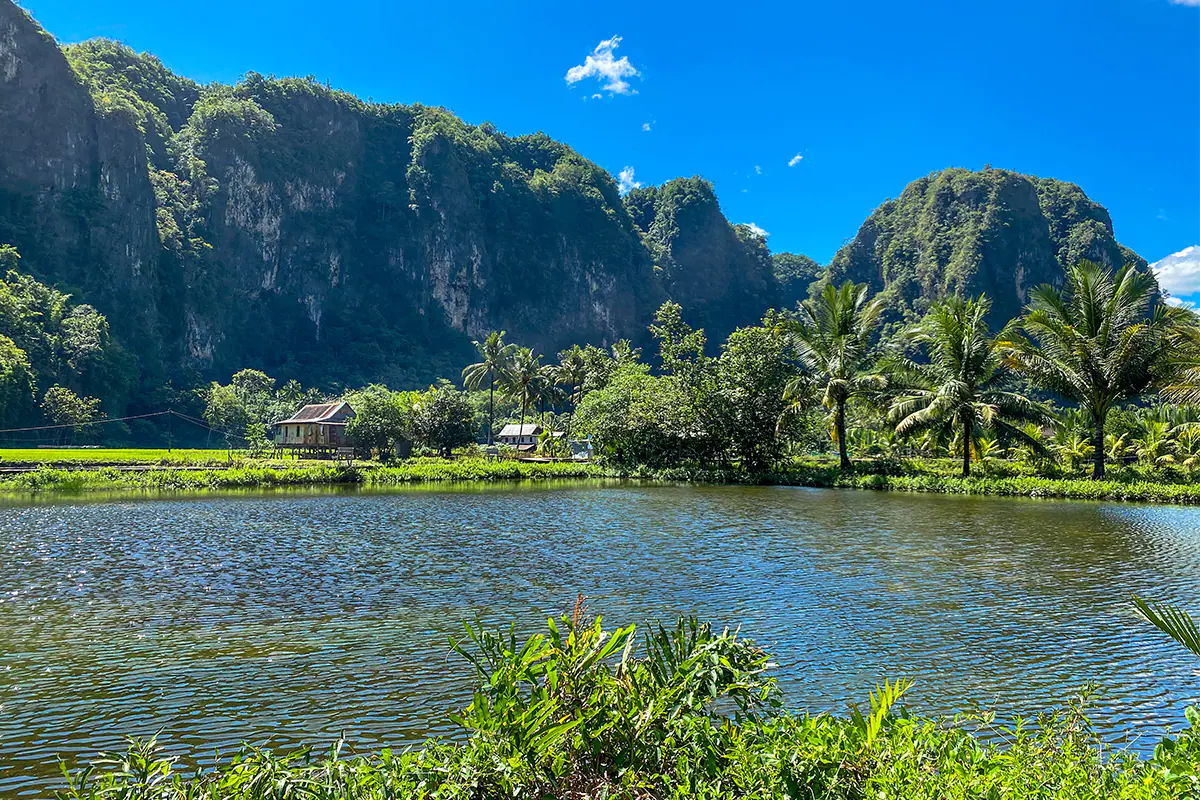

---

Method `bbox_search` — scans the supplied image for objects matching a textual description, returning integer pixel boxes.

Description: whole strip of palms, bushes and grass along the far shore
[11,261,1200,503]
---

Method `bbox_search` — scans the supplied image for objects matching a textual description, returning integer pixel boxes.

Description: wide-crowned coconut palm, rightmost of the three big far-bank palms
[1003,261,1188,480]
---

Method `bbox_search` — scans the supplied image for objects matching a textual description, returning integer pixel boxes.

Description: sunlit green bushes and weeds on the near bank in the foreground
[59,609,1200,800]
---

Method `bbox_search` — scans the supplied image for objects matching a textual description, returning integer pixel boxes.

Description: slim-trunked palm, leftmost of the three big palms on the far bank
[780,281,886,469]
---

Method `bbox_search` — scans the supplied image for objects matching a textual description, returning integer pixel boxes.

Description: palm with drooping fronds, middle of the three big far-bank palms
[888,295,1051,477]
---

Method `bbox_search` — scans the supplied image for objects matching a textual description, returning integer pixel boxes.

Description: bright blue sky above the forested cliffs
[23,0,1200,271]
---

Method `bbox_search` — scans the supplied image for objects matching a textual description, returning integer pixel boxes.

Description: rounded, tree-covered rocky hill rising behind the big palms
[829,169,1146,323]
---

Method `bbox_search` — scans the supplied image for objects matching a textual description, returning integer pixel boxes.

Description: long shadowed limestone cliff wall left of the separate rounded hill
[0,0,769,385]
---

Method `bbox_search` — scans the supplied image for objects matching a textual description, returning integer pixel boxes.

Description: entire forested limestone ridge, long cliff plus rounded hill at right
[0,0,1145,438]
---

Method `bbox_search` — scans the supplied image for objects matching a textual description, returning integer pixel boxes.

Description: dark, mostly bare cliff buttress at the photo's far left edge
[0,1,160,367]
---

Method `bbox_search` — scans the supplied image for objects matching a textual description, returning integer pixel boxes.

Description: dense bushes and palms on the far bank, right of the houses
[575,263,1200,481]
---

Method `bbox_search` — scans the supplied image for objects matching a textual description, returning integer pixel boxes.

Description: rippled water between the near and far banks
[0,485,1200,794]
